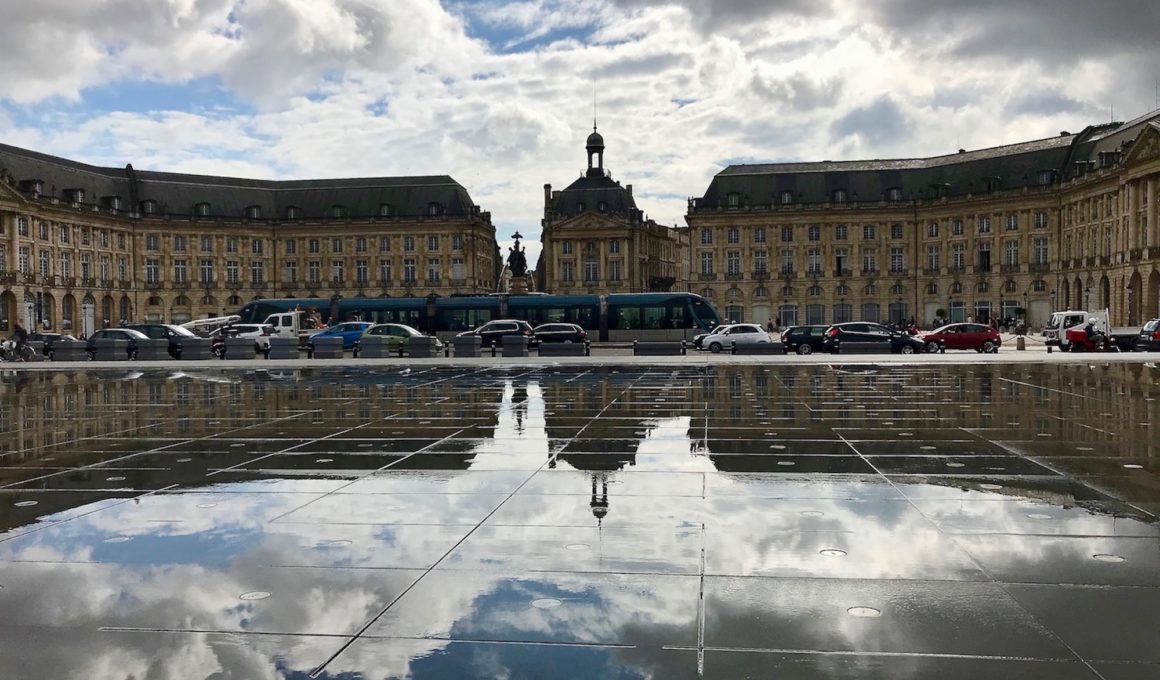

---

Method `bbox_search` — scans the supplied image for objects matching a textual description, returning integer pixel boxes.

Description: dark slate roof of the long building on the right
[693,111,1160,210]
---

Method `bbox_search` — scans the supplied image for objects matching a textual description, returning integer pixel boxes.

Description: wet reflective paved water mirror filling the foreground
[0,362,1160,680]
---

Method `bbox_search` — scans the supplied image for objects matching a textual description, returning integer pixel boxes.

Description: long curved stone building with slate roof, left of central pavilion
[0,145,499,334]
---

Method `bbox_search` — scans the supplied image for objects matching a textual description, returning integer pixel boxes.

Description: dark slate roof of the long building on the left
[0,144,479,219]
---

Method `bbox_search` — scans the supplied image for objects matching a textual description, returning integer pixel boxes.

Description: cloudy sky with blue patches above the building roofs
[0,0,1160,266]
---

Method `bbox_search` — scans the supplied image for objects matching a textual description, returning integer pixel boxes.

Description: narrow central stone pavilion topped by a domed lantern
[536,128,689,294]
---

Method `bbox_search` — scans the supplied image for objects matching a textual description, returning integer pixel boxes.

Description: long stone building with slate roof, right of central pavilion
[686,113,1160,326]
